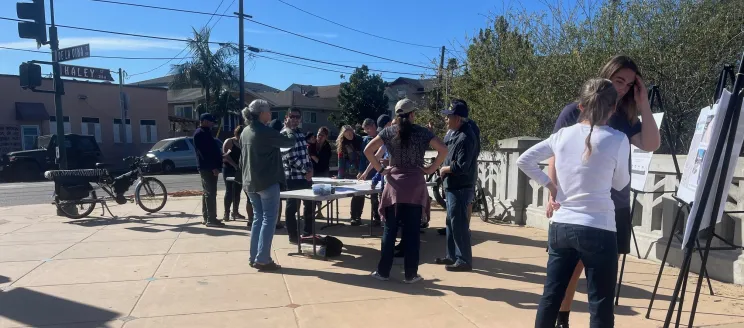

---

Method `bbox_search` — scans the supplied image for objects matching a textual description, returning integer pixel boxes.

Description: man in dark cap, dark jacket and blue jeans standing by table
[436,99,477,271]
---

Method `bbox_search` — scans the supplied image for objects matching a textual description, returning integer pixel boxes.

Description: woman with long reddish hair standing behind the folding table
[336,125,364,226]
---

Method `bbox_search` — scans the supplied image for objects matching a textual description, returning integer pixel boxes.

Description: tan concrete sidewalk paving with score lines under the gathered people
[0,197,744,328]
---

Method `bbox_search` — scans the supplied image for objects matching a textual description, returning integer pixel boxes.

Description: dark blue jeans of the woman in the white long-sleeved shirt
[535,222,617,328]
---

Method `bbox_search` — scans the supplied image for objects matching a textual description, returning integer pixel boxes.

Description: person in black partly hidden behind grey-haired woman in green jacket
[222,125,248,221]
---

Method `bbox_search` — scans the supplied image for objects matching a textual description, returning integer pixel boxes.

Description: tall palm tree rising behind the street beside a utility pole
[170,27,238,118]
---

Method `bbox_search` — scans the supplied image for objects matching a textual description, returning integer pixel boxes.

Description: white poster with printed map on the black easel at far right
[680,90,744,247]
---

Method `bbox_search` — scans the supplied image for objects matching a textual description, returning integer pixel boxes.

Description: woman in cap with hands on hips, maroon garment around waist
[364,99,447,284]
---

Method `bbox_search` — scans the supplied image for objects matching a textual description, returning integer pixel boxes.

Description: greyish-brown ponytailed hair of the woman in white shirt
[579,78,617,162]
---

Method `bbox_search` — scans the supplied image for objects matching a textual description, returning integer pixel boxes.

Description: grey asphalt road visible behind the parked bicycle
[0,174,225,207]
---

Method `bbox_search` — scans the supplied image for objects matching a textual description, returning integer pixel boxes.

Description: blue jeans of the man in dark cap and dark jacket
[445,188,474,265]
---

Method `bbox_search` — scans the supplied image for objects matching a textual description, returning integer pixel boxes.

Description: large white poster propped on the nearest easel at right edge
[678,90,744,247]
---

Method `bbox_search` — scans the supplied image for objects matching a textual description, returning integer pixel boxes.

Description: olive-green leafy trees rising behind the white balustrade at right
[445,0,744,152]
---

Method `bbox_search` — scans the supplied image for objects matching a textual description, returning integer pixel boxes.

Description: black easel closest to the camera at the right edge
[664,54,744,328]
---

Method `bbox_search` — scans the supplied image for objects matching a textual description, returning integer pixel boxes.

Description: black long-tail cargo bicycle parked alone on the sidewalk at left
[44,156,168,219]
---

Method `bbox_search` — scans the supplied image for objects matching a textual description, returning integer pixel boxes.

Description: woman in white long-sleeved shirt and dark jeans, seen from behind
[517,79,630,328]
